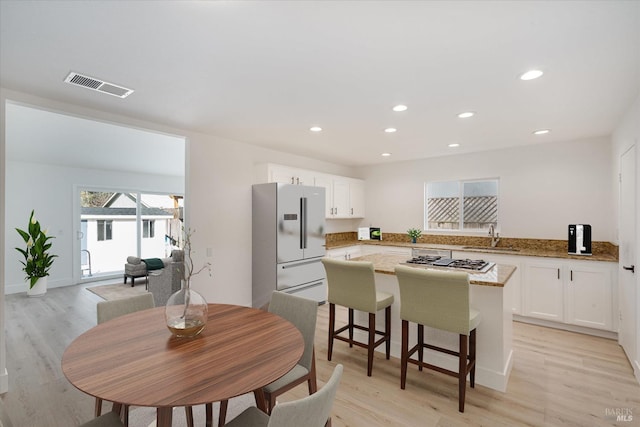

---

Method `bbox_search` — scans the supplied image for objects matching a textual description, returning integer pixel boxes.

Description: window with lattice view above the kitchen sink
[425,179,499,231]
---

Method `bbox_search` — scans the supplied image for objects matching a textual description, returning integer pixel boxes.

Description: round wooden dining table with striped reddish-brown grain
[62,304,304,427]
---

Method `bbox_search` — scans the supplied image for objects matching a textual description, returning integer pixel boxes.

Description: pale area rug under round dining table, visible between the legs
[129,393,256,427]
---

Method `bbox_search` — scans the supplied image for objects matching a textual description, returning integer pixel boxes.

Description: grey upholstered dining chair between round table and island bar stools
[214,291,318,426]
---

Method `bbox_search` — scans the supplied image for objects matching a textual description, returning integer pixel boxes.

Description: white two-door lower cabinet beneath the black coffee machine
[523,258,616,331]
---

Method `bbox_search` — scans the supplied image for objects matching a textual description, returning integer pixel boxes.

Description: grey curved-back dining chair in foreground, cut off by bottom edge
[226,364,343,427]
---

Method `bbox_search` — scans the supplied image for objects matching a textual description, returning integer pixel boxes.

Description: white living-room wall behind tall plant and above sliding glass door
[4,160,184,293]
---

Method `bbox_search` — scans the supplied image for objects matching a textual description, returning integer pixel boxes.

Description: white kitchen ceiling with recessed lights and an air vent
[0,0,640,165]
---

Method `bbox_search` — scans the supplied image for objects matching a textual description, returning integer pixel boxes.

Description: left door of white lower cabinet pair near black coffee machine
[524,262,564,322]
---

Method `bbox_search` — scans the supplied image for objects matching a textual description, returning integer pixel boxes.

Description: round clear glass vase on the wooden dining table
[165,286,209,338]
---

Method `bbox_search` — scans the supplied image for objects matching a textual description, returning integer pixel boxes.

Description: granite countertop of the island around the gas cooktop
[350,254,516,288]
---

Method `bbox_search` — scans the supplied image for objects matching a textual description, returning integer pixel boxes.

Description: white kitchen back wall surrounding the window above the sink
[360,138,615,241]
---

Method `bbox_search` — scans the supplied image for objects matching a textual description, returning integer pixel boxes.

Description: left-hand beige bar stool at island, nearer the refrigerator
[322,258,393,376]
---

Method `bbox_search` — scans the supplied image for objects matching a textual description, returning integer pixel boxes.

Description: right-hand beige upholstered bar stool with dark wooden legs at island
[395,265,481,412]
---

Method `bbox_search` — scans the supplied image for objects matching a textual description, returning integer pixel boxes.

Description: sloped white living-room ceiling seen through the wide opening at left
[6,103,185,177]
